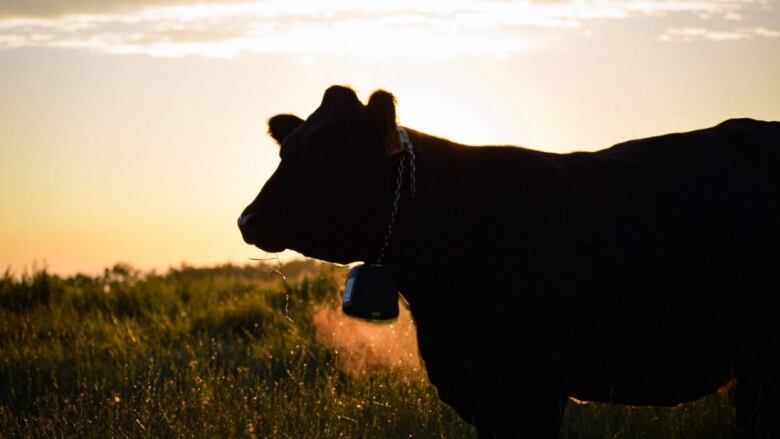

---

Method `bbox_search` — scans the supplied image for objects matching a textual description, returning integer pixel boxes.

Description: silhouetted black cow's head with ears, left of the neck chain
[238,86,401,263]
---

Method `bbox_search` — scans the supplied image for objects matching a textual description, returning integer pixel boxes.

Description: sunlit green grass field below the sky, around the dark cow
[0,262,735,438]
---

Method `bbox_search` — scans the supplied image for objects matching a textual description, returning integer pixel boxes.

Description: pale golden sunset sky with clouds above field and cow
[0,0,780,274]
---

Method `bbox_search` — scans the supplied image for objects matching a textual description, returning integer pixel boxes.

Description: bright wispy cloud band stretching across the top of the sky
[0,0,776,57]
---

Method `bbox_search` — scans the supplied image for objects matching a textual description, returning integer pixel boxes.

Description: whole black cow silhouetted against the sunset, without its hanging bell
[238,86,780,438]
